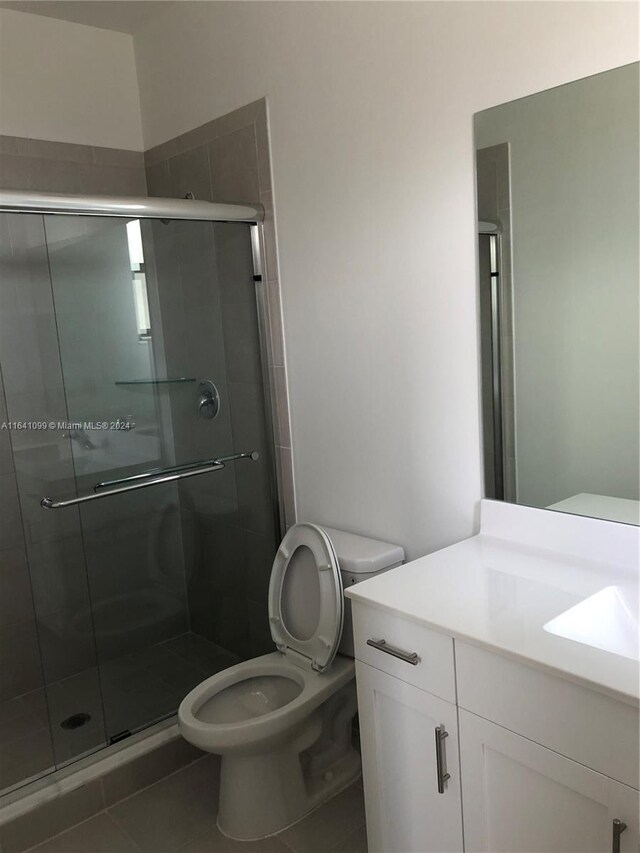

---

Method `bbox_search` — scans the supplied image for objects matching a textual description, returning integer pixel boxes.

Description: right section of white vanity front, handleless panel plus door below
[454,641,640,853]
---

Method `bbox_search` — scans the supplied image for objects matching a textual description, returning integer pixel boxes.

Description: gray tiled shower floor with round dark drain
[0,634,239,792]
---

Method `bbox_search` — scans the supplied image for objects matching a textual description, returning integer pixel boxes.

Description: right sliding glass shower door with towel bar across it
[45,216,276,741]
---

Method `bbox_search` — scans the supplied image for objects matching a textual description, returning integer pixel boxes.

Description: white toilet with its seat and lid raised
[178,523,404,840]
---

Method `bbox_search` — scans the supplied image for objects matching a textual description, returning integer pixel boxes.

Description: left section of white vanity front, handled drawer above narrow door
[353,604,462,853]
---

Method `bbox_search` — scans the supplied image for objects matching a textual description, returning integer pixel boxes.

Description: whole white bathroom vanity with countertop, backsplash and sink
[346,500,640,853]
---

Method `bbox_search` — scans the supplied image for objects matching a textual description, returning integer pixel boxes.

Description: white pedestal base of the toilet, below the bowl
[218,682,361,841]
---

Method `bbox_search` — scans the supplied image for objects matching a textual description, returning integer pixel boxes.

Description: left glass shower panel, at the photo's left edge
[0,214,106,790]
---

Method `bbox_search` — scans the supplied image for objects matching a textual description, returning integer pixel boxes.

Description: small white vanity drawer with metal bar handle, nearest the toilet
[353,601,456,703]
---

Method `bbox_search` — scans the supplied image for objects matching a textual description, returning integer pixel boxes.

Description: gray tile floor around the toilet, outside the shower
[25,756,367,853]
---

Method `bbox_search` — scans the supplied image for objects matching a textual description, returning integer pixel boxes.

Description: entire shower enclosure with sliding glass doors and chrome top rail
[0,193,280,792]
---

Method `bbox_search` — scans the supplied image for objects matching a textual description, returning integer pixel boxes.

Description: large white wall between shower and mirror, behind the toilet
[136,2,638,557]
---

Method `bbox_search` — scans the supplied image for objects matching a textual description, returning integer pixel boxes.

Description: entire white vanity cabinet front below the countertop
[353,602,640,853]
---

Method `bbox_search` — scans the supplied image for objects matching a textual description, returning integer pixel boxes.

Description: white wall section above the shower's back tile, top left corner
[0,9,142,151]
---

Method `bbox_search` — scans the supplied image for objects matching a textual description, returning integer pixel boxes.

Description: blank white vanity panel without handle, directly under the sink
[455,641,640,789]
